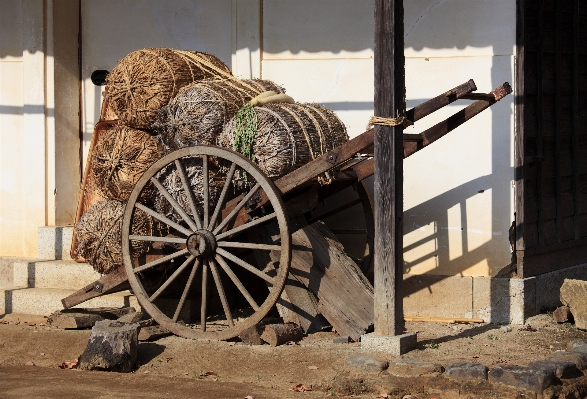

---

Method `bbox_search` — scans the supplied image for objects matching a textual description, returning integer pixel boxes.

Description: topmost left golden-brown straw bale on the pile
[104,48,232,129]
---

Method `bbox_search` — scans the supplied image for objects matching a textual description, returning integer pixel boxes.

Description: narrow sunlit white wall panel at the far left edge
[0,0,46,256]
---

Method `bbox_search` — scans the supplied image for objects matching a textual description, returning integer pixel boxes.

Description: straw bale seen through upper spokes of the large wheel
[155,157,226,223]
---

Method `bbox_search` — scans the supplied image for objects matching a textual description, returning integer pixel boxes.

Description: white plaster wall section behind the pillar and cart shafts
[261,0,515,276]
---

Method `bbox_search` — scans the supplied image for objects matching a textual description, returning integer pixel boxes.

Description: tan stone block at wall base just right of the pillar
[402,274,473,317]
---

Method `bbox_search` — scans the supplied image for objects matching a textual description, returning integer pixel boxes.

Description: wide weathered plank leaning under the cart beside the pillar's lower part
[290,221,373,341]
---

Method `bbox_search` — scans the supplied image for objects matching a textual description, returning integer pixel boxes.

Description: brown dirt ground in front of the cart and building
[0,315,587,399]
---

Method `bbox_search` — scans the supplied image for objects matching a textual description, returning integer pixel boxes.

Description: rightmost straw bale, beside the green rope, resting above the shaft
[218,103,348,179]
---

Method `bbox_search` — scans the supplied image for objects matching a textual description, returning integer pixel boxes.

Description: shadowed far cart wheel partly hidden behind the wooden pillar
[308,181,375,284]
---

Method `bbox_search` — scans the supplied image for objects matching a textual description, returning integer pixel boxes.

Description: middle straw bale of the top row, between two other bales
[152,79,283,152]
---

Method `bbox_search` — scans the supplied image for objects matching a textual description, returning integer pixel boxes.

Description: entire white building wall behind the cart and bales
[0,0,515,276]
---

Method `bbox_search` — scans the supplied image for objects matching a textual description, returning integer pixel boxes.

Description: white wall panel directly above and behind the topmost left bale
[82,0,237,165]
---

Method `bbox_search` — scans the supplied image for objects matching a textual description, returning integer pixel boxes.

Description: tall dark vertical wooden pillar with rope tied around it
[374,0,405,336]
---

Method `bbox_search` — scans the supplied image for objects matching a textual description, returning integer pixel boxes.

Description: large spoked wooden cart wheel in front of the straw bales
[122,146,291,340]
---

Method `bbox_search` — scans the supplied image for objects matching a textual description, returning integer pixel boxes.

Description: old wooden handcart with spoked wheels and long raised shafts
[62,80,512,339]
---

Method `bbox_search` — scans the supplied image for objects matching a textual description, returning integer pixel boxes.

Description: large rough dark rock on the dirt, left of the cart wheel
[79,320,139,373]
